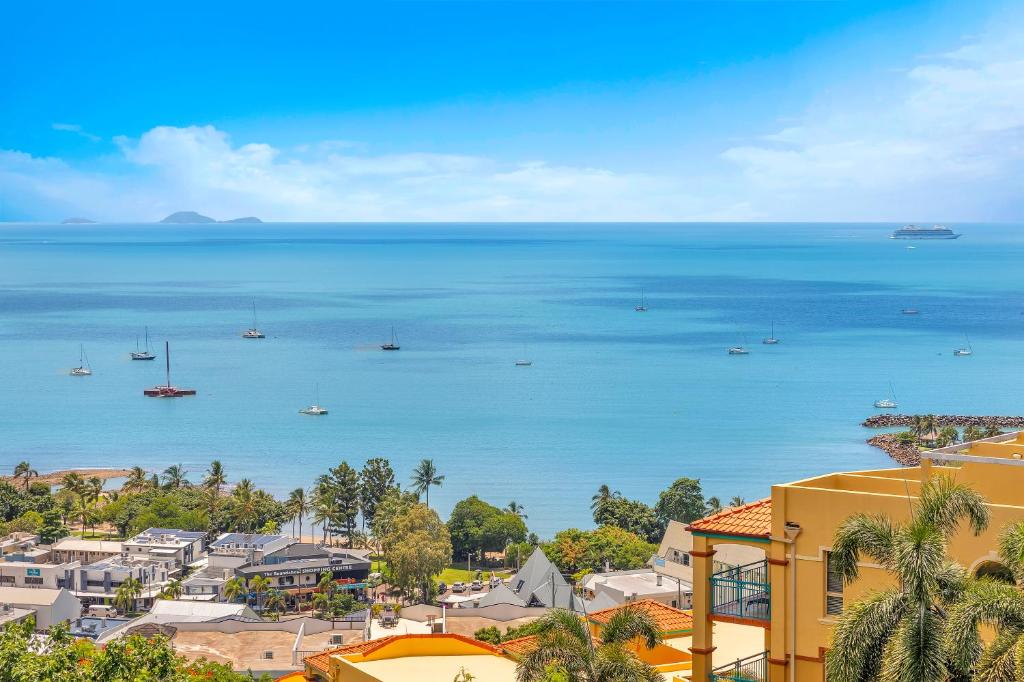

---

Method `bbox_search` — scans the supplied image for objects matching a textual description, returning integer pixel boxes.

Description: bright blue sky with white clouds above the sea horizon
[0,0,1024,222]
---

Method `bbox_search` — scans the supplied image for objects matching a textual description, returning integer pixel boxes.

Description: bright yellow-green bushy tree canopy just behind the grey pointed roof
[542,525,657,573]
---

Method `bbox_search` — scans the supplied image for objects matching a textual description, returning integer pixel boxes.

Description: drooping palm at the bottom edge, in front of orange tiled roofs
[516,606,663,682]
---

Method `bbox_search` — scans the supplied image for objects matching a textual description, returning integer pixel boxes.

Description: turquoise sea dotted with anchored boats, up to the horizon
[0,224,1024,536]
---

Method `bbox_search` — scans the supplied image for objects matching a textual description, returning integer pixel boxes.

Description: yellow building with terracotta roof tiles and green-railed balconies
[689,432,1024,682]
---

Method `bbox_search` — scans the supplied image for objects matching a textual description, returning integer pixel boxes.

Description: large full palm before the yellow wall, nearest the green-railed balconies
[825,476,989,682]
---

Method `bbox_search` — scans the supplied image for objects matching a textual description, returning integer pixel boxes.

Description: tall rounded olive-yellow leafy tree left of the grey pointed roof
[381,504,452,594]
